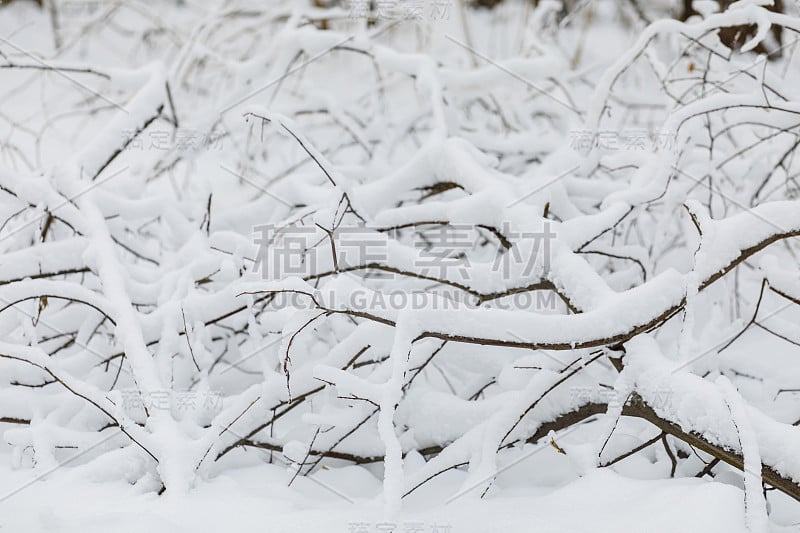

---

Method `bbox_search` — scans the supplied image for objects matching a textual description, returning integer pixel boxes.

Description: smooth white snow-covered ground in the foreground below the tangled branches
[0,438,780,533]
